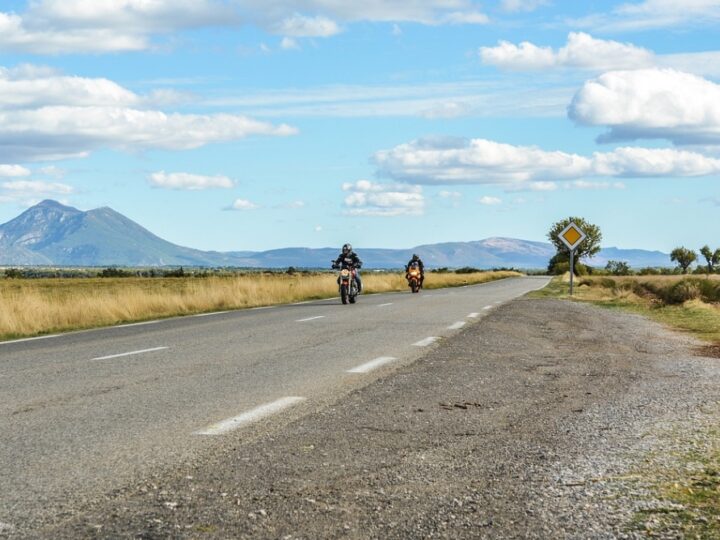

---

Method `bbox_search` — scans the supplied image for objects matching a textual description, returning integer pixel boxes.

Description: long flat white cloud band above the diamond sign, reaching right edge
[374,139,720,185]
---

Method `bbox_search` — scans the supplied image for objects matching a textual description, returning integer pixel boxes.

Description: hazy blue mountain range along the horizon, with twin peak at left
[0,200,670,268]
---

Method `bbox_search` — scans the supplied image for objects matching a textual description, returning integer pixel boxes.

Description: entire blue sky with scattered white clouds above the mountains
[0,0,720,251]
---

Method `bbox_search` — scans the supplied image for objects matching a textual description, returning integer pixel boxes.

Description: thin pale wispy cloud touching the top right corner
[569,0,720,31]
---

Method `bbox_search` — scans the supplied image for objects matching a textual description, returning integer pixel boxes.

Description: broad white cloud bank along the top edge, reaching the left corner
[0,0,488,54]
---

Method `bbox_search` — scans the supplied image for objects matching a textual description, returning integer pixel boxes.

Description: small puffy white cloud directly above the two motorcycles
[342,180,425,216]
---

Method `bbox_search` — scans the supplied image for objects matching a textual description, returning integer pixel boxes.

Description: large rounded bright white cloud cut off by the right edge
[568,69,720,145]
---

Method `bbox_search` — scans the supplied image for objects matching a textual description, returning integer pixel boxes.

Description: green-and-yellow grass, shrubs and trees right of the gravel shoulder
[531,218,720,538]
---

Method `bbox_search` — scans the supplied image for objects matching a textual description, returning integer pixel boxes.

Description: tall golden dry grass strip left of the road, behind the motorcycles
[0,272,519,339]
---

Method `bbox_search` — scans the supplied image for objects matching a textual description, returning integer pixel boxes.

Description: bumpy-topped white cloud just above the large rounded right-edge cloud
[480,32,654,71]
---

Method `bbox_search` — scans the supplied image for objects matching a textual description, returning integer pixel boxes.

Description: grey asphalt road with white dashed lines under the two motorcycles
[0,278,547,532]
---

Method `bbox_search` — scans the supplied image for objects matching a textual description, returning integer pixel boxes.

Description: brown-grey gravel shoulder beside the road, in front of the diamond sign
[15,298,720,539]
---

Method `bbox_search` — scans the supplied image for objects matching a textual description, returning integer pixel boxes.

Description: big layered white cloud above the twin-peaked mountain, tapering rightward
[0,69,297,161]
